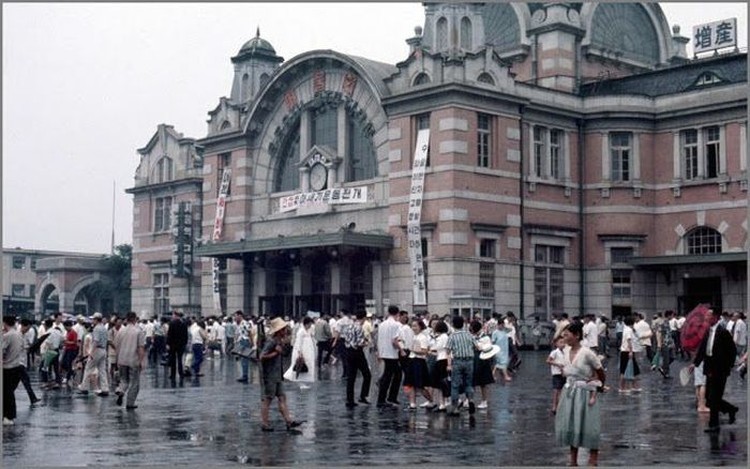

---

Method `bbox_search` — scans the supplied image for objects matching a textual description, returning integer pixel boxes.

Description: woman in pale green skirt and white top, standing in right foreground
[555,322,605,466]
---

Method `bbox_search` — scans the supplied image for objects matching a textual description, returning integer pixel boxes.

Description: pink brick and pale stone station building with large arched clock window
[130,3,748,318]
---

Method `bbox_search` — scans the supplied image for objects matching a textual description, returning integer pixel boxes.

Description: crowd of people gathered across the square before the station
[3,306,747,465]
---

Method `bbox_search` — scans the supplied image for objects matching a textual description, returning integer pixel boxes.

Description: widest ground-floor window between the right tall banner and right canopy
[534,244,565,318]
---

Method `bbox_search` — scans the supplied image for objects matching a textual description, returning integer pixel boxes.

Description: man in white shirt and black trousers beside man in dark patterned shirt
[378,305,401,407]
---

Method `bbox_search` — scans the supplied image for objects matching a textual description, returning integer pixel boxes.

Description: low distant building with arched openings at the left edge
[2,248,111,318]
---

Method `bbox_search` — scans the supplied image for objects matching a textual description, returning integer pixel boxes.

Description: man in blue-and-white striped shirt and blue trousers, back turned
[446,316,476,415]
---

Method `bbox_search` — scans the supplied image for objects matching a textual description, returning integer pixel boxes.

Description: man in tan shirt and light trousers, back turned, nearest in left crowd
[115,312,146,410]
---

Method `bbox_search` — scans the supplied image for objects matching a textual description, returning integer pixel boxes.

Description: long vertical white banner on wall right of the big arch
[406,129,430,306]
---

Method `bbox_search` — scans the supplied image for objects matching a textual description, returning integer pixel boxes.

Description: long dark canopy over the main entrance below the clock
[195,231,393,259]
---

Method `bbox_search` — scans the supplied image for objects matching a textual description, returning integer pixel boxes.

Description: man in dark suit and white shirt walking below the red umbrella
[690,310,739,433]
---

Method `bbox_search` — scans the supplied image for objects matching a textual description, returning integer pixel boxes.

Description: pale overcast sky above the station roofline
[2,2,747,253]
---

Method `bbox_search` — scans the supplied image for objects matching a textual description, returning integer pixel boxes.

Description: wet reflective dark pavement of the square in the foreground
[2,351,748,467]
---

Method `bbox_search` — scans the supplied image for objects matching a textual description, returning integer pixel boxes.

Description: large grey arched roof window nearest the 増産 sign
[591,3,659,65]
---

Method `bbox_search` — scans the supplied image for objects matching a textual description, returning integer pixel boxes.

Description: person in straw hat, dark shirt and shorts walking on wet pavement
[260,318,302,432]
